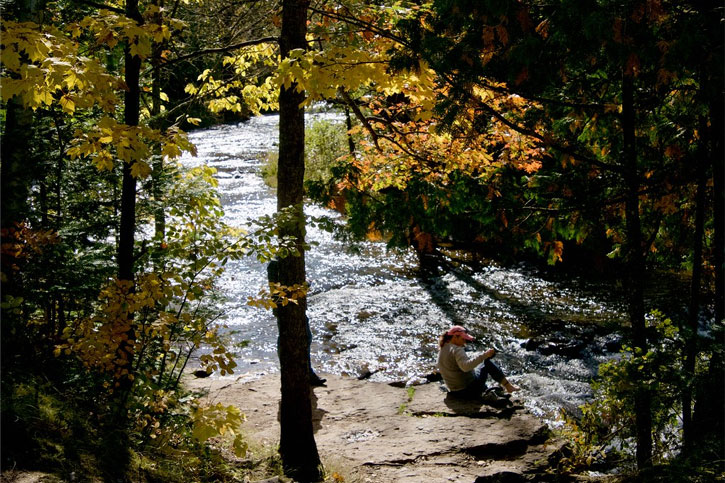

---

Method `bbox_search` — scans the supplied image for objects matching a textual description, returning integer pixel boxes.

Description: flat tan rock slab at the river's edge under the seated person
[186,374,561,483]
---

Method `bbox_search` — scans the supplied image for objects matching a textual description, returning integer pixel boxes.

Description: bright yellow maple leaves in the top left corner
[0,15,194,178]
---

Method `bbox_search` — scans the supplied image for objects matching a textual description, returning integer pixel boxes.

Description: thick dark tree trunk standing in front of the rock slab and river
[276,0,322,481]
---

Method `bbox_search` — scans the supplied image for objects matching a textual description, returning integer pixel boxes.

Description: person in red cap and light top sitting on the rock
[438,325,519,399]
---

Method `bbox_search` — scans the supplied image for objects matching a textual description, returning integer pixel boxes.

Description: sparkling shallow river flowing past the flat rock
[182,114,625,419]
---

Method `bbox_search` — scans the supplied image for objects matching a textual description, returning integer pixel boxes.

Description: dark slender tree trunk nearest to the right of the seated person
[622,73,652,469]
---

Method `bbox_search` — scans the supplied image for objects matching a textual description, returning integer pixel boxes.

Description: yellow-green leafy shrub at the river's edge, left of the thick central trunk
[57,164,239,390]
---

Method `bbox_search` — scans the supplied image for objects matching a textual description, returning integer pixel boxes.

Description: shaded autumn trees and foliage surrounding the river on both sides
[0,0,725,481]
